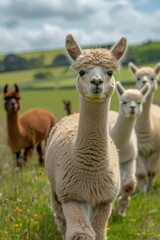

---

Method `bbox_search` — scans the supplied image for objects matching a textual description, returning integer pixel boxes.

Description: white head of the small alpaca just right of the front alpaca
[116,82,150,118]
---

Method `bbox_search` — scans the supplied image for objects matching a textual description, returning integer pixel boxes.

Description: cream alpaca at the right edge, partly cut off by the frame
[129,63,160,191]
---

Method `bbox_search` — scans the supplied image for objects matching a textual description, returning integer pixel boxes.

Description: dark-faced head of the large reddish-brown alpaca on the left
[3,84,21,113]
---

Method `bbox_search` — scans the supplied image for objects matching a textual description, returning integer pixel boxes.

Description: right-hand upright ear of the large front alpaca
[111,37,127,60]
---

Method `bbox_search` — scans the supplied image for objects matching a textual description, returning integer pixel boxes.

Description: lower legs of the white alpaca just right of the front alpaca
[118,159,137,216]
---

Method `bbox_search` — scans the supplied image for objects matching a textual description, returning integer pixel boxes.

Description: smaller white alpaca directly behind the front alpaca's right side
[109,82,150,215]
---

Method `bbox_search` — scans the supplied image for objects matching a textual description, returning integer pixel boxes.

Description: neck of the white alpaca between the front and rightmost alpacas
[111,112,135,147]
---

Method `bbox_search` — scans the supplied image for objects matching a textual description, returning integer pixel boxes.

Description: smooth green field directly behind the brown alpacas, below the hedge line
[0,85,160,119]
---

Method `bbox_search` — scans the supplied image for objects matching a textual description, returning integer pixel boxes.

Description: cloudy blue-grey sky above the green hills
[0,0,160,54]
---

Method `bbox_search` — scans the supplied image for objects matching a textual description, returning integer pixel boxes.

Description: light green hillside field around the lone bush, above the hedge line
[0,63,158,89]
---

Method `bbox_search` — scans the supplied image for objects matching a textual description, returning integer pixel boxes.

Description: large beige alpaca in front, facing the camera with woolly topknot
[45,35,126,240]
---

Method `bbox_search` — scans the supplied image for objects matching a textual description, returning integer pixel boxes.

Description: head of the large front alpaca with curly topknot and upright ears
[66,35,127,101]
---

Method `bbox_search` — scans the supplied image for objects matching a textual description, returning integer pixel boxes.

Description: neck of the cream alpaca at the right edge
[136,95,153,133]
